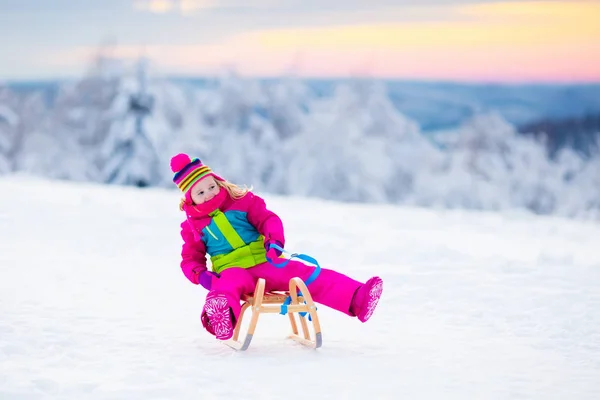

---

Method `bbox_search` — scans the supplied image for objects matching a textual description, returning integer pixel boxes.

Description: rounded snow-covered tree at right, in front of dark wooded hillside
[432,112,576,214]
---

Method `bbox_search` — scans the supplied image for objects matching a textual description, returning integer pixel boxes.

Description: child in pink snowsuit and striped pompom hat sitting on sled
[171,154,383,340]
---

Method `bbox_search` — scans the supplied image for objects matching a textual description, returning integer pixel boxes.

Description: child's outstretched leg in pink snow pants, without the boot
[248,261,362,316]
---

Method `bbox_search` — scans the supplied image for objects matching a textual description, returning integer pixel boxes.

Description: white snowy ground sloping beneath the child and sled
[0,177,600,400]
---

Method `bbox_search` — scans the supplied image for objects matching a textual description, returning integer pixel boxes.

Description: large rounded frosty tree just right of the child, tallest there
[283,82,432,202]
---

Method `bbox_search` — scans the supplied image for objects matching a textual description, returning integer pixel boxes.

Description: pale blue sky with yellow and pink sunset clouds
[0,0,600,82]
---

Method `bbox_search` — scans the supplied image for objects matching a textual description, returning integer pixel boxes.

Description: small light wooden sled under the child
[223,278,323,351]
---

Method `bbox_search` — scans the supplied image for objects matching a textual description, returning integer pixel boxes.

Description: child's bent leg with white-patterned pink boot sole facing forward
[200,268,255,340]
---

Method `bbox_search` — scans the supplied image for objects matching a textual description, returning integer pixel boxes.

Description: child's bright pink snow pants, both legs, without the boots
[202,260,362,332]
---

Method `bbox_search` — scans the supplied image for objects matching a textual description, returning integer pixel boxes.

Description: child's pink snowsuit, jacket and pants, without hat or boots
[176,189,361,334]
